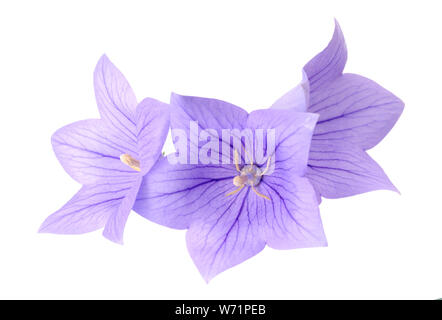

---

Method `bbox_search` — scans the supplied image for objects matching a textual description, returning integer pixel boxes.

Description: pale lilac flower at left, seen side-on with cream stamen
[39,56,169,243]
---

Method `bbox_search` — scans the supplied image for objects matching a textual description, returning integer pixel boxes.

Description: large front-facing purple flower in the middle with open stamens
[134,94,327,281]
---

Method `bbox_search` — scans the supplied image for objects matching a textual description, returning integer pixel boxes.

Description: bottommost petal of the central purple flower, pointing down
[186,188,265,282]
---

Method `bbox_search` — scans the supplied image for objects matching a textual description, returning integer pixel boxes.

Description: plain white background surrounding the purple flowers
[0,0,442,299]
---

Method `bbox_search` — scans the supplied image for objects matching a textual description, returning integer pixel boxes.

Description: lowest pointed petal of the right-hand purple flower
[306,141,397,198]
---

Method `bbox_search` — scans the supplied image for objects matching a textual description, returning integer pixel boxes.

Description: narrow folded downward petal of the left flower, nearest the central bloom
[103,176,142,244]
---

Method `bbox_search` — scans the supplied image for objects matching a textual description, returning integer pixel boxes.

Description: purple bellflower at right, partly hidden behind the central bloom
[272,22,404,199]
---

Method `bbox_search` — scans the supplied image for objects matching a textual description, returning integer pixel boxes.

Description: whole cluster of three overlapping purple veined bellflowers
[40,23,404,281]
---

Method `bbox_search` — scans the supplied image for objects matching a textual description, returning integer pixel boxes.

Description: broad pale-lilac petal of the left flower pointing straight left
[52,120,140,184]
